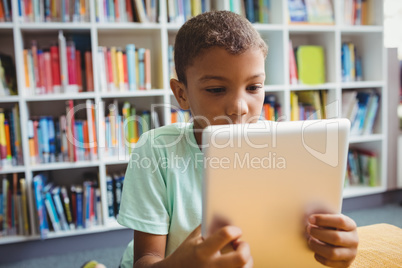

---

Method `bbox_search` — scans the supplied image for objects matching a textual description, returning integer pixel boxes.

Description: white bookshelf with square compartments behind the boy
[0,0,387,244]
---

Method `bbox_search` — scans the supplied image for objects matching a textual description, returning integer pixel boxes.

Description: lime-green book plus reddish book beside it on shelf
[289,40,325,85]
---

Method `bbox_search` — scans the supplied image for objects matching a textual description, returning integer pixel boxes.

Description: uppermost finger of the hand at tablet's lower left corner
[198,225,242,256]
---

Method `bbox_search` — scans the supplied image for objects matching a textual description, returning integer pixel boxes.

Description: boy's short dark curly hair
[174,11,268,85]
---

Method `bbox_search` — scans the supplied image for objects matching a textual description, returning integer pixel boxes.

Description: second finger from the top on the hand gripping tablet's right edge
[308,225,359,247]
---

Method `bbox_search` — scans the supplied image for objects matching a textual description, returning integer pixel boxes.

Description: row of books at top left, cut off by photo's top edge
[18,0,90,22]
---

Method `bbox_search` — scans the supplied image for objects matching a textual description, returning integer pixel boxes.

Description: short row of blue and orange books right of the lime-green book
[341,43,363,82]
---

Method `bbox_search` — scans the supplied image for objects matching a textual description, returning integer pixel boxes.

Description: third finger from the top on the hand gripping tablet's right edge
[308,238,357,261]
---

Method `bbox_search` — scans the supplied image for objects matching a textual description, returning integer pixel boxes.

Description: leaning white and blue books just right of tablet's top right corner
[342,90,380,135]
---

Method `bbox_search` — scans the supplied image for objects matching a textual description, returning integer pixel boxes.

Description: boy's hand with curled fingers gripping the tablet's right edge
[307,214,359,267]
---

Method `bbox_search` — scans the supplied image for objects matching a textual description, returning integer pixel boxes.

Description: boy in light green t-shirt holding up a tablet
[118,11,358,267]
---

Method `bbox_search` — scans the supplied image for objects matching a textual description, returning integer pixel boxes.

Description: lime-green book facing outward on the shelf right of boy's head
[296,46,325,85]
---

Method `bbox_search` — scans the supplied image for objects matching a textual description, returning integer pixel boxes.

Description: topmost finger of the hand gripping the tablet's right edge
[309,214,356,231]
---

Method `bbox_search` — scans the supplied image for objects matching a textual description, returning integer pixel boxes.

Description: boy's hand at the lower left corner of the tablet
[168,225,253,268]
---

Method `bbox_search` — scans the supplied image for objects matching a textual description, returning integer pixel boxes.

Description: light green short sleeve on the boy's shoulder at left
[117,132,170,235]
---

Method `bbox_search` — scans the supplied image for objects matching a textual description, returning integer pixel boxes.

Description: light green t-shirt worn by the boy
[117,123,204,267]
